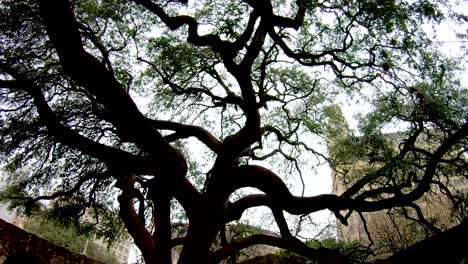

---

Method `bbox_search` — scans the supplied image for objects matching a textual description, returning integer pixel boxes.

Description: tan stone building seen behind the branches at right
[328,105,468,255]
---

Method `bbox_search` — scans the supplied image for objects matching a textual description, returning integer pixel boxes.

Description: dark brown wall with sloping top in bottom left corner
[0,219,102,264]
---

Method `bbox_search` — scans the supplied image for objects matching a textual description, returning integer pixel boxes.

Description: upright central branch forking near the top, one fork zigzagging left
[134,0,267,162]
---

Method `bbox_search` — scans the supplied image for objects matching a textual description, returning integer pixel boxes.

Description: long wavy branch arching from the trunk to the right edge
[220,146,468,223]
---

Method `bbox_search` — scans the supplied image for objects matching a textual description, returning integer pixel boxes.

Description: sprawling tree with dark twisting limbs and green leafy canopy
[0,0,468,263]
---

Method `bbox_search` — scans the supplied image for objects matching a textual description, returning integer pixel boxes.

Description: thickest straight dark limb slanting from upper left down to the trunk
[38,0,187,177]
